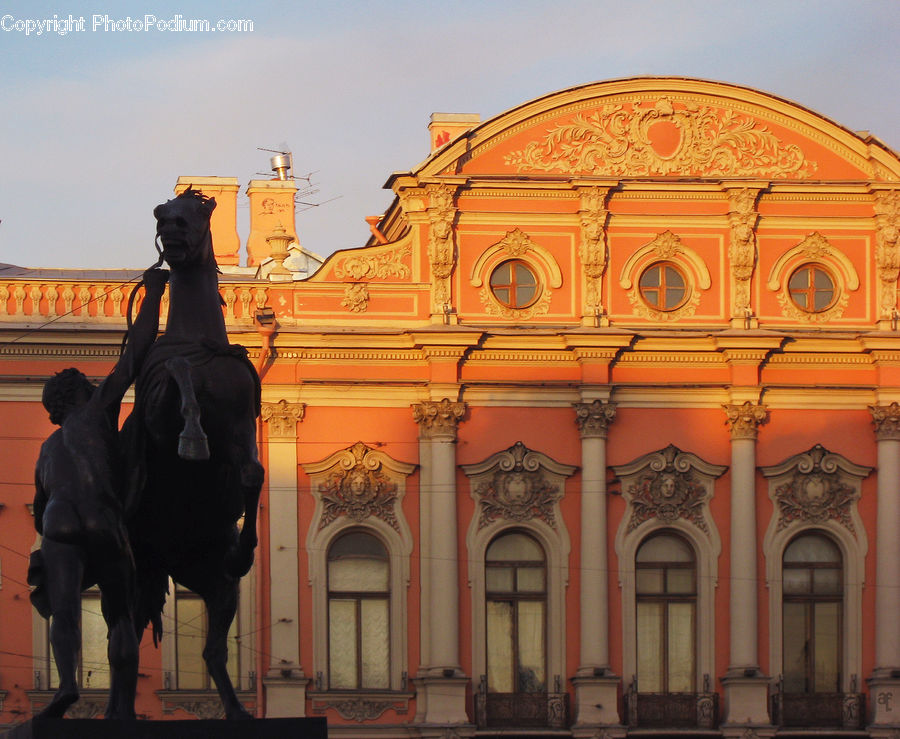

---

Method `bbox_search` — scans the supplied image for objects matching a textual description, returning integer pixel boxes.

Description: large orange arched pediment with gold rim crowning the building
[418,77,900,180]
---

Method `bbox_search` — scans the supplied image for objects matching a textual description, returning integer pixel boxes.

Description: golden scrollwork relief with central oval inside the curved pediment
[506,97,817,178]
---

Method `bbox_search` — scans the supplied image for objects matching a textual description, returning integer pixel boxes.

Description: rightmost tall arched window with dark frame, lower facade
[782,533,844,693]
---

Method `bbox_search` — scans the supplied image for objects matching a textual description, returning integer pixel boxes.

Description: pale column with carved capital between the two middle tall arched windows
[572,400,621,730]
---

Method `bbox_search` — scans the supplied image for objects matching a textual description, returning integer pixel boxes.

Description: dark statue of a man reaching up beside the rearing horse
[28,269,169,718]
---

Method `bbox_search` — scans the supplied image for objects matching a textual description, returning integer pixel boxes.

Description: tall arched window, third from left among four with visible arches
[635,533,697,693]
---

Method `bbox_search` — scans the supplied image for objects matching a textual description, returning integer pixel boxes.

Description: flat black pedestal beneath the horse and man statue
[3,718,328,739]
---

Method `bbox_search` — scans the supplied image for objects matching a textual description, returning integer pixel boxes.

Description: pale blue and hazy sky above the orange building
[0,0,900,269]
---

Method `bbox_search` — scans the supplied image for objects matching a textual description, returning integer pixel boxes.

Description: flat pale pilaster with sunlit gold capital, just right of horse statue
[262,400,308,718]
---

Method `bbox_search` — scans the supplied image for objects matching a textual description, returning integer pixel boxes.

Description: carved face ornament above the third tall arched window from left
[627,444,709,534]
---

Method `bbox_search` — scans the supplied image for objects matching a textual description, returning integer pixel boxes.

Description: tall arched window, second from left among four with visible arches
[485,532,547,693]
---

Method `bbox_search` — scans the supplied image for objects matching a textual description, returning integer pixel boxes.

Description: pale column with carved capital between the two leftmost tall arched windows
[412,398,468,724]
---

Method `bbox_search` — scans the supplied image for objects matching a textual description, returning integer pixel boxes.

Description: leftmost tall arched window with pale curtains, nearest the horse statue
[328,530,391,690]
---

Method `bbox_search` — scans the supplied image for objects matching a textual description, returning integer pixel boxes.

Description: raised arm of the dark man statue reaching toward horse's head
[97,269,169,406]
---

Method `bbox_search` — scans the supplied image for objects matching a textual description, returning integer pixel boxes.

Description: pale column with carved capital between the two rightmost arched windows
[722,401,770,725]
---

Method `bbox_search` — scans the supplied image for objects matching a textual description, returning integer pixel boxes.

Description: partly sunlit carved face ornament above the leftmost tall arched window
[319,441,400,531]
